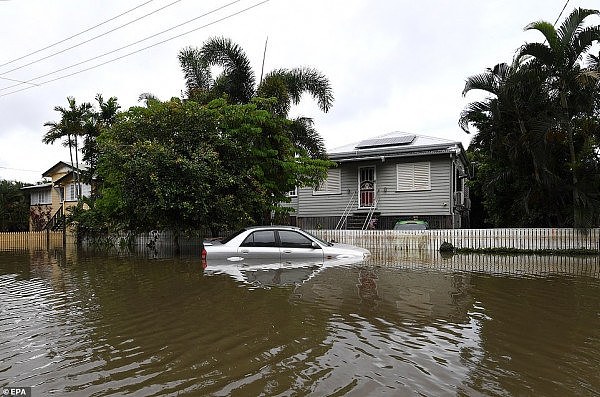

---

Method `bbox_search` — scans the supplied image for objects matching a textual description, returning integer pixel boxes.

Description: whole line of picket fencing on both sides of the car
[0,228,600,254]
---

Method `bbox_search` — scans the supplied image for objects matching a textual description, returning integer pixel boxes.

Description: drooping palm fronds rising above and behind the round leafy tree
[179,37,333,158]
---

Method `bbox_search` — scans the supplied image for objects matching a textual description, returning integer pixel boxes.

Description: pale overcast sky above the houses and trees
[0,0,600,182]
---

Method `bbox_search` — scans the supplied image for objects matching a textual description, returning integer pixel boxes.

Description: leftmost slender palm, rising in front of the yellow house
[42,97,92,198]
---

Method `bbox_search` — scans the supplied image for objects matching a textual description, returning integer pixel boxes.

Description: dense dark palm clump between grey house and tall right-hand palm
[459,62,564,226]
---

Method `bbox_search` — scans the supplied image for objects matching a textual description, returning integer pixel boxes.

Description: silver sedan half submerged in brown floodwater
[204,226,371,267]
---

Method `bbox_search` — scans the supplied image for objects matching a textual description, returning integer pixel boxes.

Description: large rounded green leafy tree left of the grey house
[96,99,330,241]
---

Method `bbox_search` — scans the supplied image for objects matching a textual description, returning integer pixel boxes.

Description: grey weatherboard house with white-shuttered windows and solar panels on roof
[284,132,471,229]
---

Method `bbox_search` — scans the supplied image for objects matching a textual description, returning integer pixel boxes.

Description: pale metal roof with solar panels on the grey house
[327,131,468,168]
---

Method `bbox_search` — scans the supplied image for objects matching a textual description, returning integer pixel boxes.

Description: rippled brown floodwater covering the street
[0,249,600,396]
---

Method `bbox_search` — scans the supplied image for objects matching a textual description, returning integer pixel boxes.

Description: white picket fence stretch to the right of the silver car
[310,228,600,253]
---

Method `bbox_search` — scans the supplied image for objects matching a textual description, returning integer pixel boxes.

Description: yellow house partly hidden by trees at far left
[22,161,91,230]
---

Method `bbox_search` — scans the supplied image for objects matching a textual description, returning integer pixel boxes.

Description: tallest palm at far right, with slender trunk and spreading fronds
[517,8,600,227]
